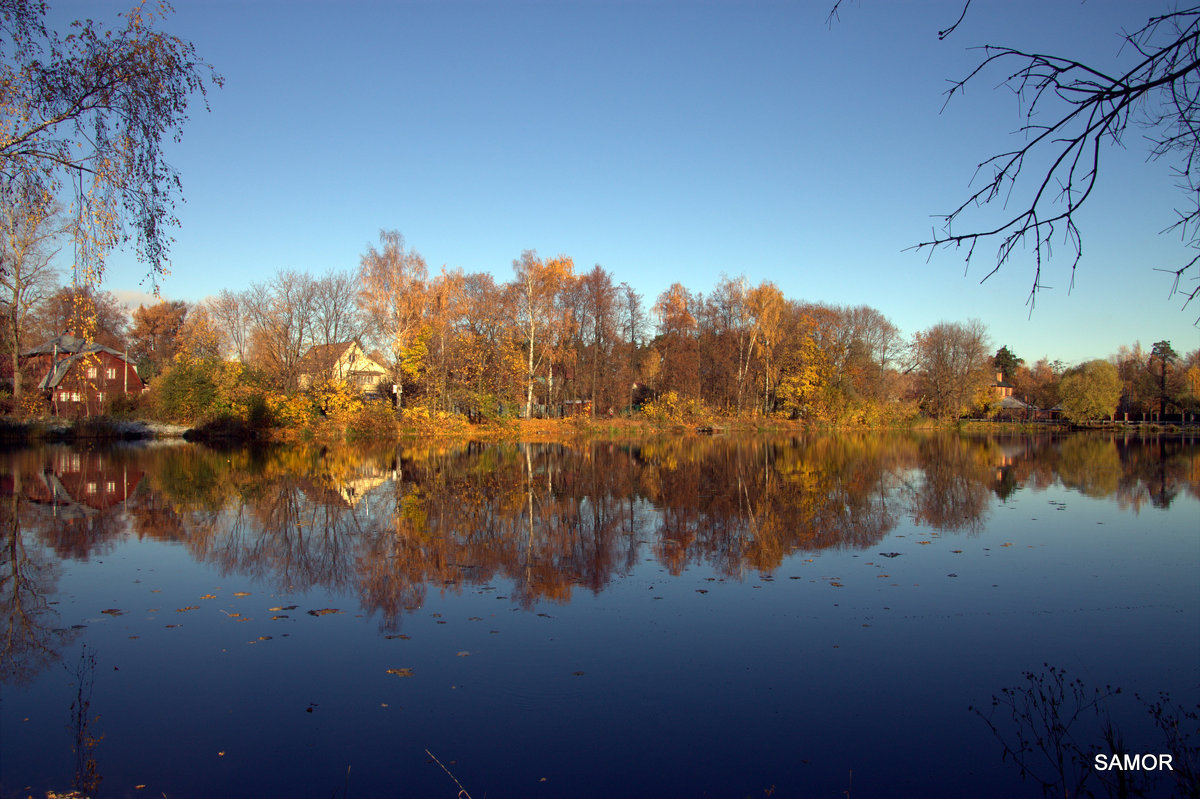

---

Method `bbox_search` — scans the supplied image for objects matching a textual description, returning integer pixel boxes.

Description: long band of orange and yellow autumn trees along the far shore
[0,224,1200,425]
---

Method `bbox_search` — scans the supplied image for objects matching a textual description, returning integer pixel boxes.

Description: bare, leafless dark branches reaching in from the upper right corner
[829,0,1200,310]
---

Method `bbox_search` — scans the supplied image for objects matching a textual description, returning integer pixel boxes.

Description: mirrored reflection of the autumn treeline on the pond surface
[0,434,1200,657]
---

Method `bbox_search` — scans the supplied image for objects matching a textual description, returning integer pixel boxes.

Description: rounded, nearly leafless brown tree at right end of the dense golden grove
[914,320,992,419]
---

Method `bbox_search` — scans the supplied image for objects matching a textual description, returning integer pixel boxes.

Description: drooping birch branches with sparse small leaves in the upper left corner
[0,0,221,286]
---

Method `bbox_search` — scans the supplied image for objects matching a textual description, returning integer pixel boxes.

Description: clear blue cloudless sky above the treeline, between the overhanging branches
[54,0,1200,364]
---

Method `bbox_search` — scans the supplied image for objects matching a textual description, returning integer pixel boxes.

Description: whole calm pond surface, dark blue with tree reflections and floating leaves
[0,435,1200,799]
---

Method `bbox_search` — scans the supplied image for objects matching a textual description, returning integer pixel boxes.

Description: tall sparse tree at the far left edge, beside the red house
[0,186,64,408]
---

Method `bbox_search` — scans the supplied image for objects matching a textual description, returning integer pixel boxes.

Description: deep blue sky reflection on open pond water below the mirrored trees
[0,436,1200,797]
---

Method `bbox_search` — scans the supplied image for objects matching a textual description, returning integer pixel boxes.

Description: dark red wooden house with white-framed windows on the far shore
[20,336,146,416]
